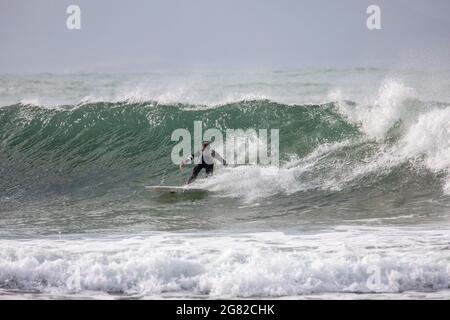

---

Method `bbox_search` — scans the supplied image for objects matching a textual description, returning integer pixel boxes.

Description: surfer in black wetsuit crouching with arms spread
[180,141,227,184]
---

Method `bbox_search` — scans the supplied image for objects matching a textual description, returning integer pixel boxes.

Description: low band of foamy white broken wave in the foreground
[0,228,450,298]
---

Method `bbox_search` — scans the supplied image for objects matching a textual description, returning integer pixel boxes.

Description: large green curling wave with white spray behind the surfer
[0,89,450,201]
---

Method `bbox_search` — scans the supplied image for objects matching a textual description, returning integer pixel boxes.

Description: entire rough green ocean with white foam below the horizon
[0,68,450,299]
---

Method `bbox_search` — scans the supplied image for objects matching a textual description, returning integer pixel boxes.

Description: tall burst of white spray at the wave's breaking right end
[338,79,450,194]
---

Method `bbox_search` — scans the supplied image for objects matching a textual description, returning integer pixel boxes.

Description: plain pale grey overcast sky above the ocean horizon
[0,0,450,73]
